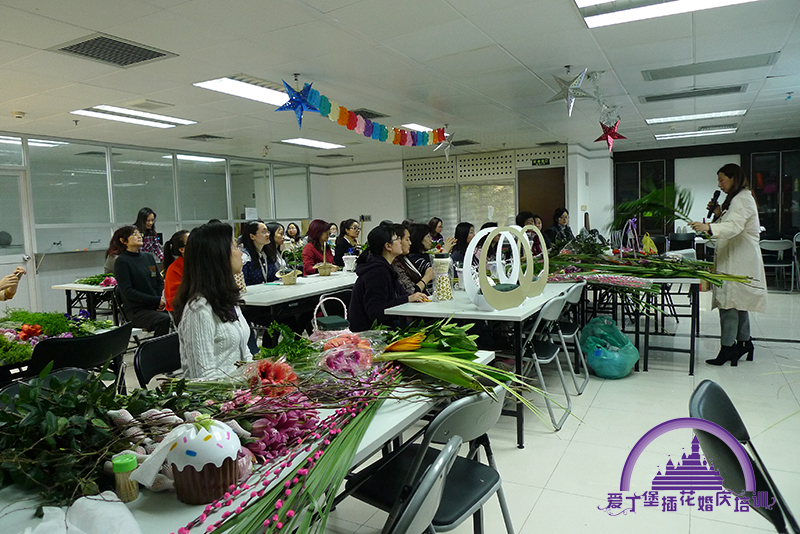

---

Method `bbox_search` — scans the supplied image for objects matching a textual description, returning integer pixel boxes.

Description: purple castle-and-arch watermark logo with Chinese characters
[597,417,775,516]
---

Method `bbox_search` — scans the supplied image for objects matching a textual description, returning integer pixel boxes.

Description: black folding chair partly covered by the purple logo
[689,380,800,534]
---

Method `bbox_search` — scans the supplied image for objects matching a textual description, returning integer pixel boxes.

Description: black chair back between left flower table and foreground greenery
[28,323,133,393]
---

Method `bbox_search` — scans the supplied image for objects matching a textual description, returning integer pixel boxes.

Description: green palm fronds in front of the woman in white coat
[611,182,692,230]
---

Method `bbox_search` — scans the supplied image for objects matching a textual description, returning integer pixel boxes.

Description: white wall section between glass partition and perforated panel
[311,162,406,239]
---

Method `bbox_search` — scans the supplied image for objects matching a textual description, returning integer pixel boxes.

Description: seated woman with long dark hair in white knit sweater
[175,223,252,379]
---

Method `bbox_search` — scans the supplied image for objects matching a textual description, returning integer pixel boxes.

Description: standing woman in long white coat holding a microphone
[691,163,767,367]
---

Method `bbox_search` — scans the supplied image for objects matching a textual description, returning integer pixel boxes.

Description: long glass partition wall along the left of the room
[6,136,310,254]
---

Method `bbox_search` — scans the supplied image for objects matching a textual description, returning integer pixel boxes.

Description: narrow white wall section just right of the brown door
[567,149,614,235]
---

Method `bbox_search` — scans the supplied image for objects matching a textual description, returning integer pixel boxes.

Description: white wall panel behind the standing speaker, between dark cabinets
[675,154,740,231]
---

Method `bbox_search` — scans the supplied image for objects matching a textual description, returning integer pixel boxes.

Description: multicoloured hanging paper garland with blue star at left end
[275,81,446,146]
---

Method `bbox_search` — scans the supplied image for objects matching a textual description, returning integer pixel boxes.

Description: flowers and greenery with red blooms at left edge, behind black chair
[0,309,112,365]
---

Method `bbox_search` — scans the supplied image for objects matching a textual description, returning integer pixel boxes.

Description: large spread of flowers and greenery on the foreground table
[0,321,552,534]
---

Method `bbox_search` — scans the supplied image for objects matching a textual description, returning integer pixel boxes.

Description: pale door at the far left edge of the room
[0,171,36,316]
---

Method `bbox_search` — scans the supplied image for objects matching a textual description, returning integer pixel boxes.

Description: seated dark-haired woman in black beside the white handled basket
[347,225,427,332]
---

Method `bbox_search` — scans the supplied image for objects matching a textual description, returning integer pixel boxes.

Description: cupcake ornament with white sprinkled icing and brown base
[131,416,241,504]
